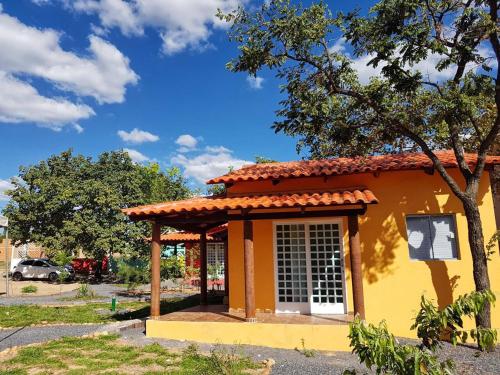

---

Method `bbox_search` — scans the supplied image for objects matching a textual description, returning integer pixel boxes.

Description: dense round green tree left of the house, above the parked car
[4,150,190,260]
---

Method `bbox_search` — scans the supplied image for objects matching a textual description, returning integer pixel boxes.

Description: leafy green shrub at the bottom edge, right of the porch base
[344,317,453,375]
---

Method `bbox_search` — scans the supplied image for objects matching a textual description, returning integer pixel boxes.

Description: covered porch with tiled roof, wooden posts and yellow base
[125,189,378,350]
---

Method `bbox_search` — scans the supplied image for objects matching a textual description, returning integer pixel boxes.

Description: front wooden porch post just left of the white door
[243,220,257,323]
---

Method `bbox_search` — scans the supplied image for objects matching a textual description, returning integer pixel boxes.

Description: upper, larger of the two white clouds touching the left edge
[0,13,138,103]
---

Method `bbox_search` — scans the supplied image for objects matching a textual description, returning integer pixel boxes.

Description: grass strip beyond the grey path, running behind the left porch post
[0,297,198,328]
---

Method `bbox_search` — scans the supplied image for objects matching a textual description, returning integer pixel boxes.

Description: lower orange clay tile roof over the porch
[123,189,378,218]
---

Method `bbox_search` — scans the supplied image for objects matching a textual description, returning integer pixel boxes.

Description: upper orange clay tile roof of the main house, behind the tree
[207,151,500,184]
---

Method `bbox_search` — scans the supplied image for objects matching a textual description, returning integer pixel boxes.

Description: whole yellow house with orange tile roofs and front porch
[125,151,500,350]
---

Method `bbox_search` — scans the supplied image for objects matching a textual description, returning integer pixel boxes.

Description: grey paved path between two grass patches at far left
[0,324,103,350]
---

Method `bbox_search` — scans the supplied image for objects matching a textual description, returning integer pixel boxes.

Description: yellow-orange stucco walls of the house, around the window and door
[228,170,500,337]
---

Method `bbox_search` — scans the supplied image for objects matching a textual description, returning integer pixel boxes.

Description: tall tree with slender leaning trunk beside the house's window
[219,0,500,327]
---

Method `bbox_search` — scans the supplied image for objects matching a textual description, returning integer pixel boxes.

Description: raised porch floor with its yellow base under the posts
[146,305,352,351]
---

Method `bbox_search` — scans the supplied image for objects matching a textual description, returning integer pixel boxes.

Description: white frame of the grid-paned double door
[272,217,348,315]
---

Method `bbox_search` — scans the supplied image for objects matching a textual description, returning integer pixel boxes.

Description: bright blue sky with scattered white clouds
[0,0,376,205]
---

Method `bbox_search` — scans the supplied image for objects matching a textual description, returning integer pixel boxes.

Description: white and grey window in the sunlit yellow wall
[406,215,458,260]
